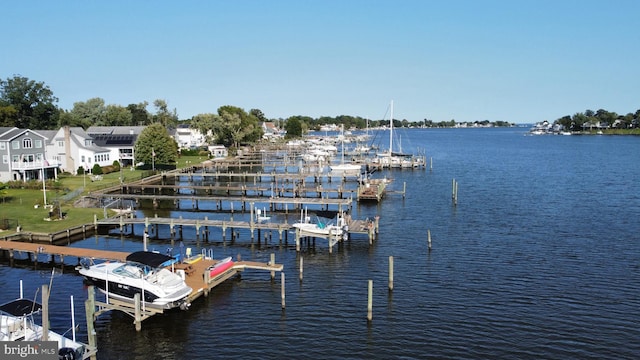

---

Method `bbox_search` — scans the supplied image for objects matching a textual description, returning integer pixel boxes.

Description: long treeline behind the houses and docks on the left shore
[0,75,511,141]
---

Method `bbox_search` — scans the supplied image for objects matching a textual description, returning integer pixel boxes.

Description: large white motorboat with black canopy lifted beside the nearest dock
[78,251,193,310]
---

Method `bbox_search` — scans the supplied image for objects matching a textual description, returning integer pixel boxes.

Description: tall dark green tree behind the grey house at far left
[0,75,60,130]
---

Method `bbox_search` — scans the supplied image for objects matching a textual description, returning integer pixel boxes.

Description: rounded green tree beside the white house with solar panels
[134,123,178,167]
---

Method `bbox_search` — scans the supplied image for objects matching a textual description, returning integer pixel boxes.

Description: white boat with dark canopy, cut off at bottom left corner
[0,298,90,359]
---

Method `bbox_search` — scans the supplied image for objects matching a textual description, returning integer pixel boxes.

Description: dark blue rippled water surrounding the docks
[0,128,640,359]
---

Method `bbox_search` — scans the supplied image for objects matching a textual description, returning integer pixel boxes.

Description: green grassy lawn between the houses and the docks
[0,156,206,237]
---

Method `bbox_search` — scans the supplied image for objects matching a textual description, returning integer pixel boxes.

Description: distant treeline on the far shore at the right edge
[554,109,640,131]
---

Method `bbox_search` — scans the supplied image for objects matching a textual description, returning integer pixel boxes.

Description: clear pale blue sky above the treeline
[0,0,640,123]
